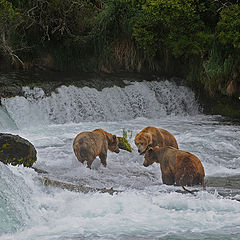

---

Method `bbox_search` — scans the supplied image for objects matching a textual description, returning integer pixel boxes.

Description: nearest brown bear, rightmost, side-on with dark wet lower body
[143,146,205,189]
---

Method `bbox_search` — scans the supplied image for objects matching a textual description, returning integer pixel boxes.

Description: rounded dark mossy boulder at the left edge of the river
[0,133,37,167]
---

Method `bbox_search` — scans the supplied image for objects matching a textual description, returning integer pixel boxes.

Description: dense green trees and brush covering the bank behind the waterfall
[0,0,240,107]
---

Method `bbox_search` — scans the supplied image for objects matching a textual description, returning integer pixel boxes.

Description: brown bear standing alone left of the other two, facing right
[73,129,119,169]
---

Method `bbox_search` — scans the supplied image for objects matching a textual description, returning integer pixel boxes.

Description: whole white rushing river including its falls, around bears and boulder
[0,79,240,240]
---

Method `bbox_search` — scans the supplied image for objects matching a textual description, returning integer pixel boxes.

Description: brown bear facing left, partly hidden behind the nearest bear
[134,127,178,155]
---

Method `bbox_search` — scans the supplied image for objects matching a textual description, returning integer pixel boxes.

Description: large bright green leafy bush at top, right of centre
[133,0,211,57]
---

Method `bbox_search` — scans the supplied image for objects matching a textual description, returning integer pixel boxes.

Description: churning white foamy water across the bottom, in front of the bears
[1,167,240,240]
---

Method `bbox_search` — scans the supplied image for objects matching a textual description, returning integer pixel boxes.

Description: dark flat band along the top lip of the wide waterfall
[0,71,156,98]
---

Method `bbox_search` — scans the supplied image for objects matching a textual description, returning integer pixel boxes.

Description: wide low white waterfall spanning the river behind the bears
[2,81,199,128]
